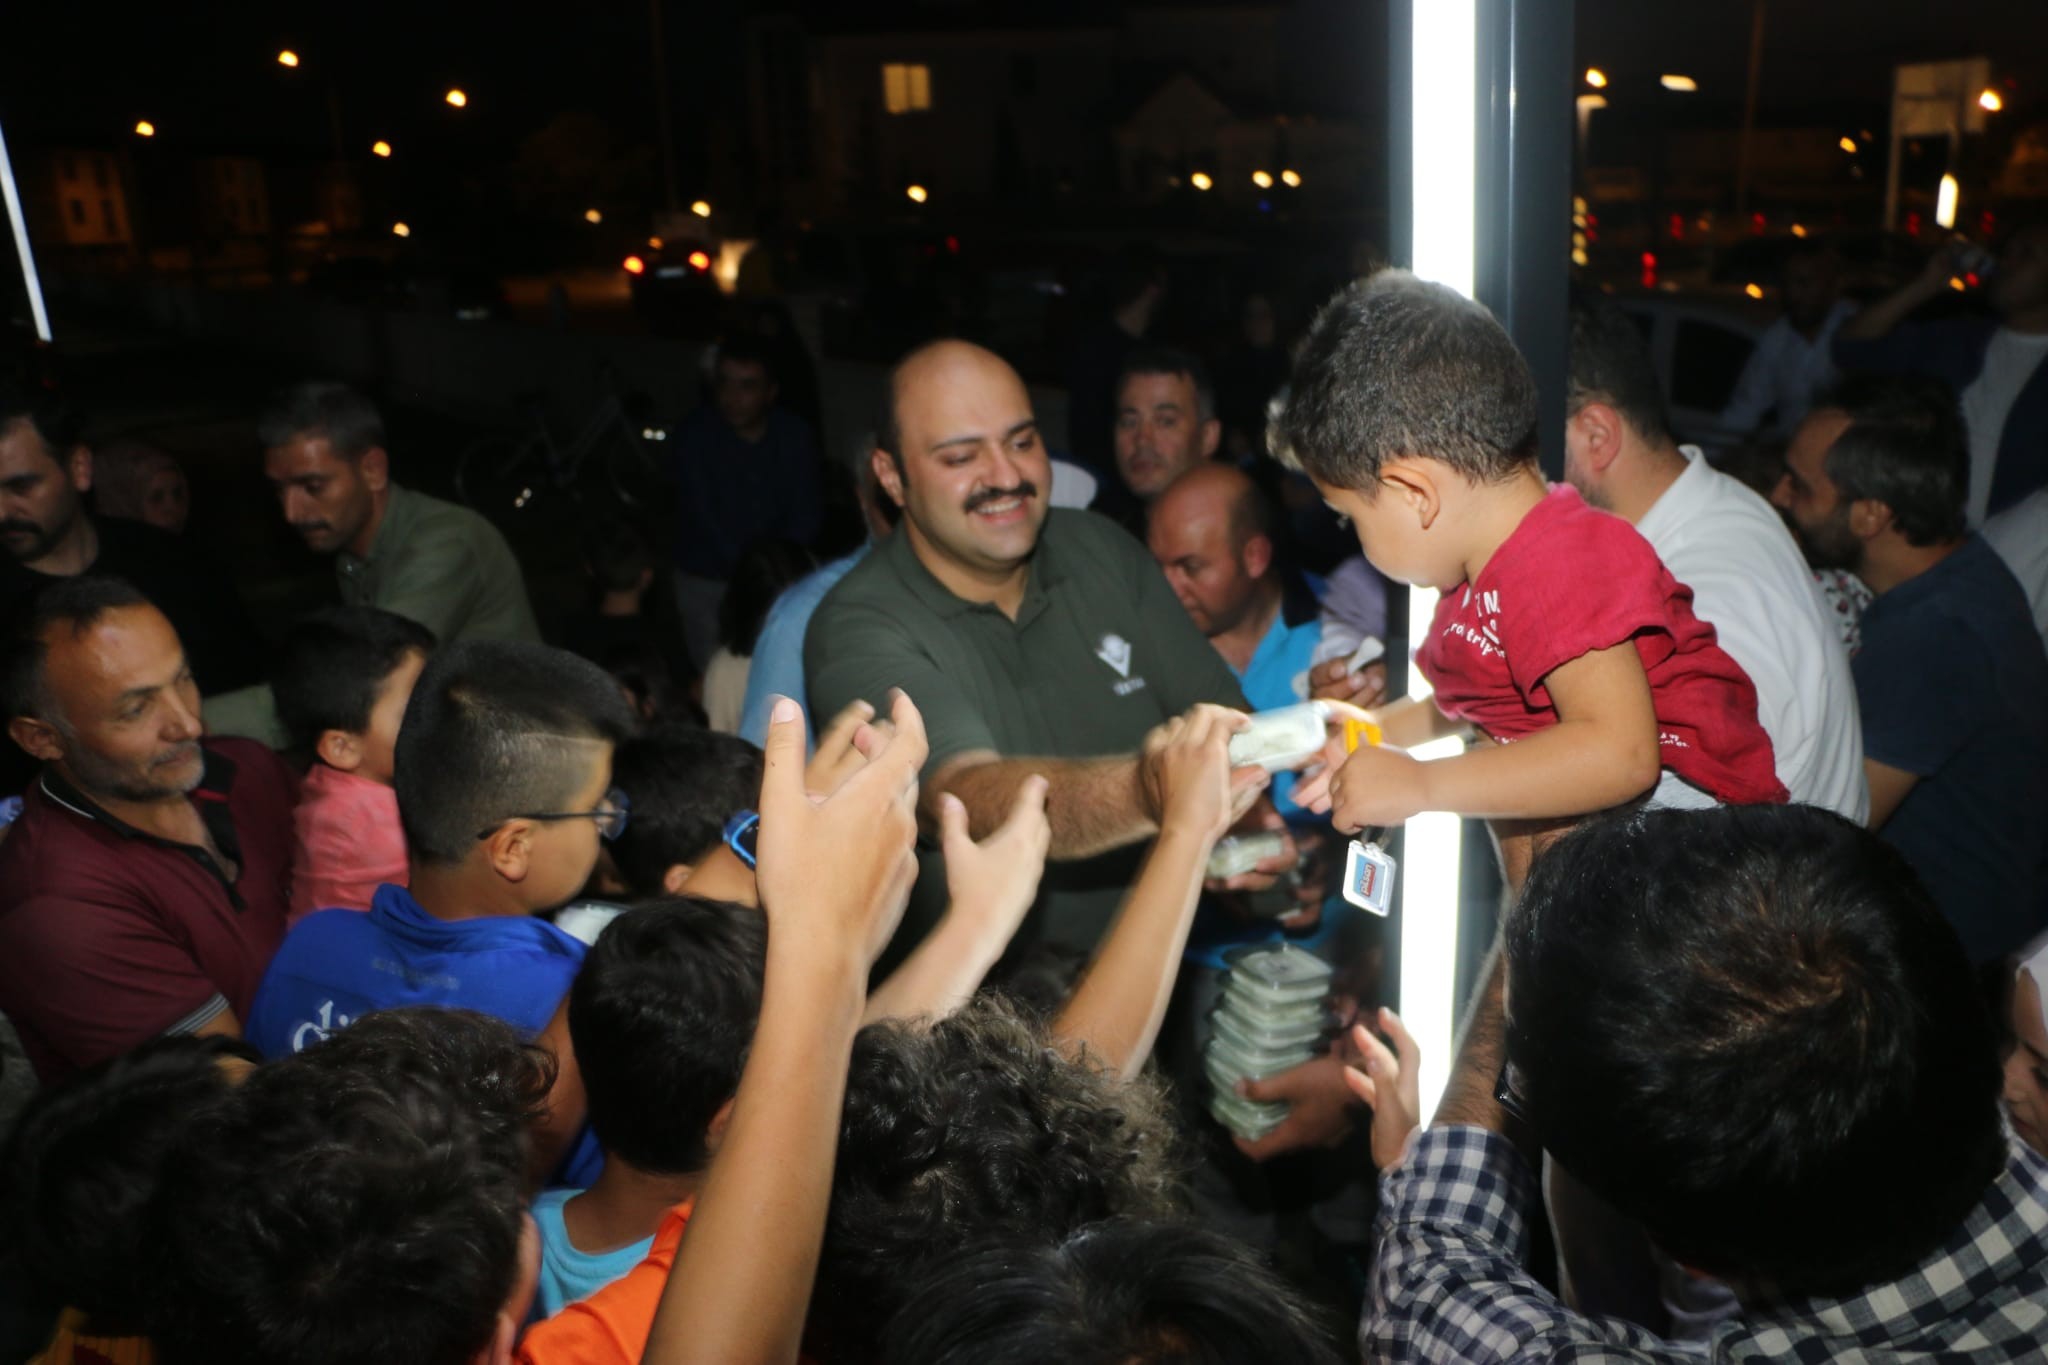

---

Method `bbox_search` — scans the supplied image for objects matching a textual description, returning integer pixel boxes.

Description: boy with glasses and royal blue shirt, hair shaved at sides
[244,641,633,1169]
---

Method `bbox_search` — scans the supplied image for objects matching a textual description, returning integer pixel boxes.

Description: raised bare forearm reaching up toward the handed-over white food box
[1053,829,1214,1078]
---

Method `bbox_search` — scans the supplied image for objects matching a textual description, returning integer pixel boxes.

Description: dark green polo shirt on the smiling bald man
[803,508,1245,952]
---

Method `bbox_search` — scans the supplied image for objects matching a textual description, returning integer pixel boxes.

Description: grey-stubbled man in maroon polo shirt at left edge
[0,575,297,1083]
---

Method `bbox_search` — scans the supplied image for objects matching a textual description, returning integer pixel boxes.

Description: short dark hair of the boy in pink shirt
[270,606,434,749]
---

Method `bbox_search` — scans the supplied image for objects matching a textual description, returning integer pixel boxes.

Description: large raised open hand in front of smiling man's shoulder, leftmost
[756,692,930,972]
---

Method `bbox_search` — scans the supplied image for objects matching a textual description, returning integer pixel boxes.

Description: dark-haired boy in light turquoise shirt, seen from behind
[532,896,768,1316]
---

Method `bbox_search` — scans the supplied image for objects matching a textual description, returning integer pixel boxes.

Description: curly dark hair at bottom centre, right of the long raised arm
[807,997,1182,1365]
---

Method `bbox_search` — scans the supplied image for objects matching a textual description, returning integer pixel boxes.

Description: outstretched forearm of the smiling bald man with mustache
[924,753,1157,862]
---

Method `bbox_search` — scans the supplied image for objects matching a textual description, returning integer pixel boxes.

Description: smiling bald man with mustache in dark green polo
[805,342,1292,954]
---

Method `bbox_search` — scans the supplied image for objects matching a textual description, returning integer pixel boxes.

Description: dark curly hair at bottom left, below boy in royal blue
[145,1009,553,1365]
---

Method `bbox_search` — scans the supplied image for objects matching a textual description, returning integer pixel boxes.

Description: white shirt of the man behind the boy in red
[1636,446,1870,825]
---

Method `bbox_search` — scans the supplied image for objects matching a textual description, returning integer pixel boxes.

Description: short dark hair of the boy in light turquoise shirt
[569,896,768,1175]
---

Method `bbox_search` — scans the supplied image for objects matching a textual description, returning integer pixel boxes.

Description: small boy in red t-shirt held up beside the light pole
[1278,270,1786,882]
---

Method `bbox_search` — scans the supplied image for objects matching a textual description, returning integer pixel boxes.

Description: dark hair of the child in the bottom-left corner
[0,1033,260,1336]
